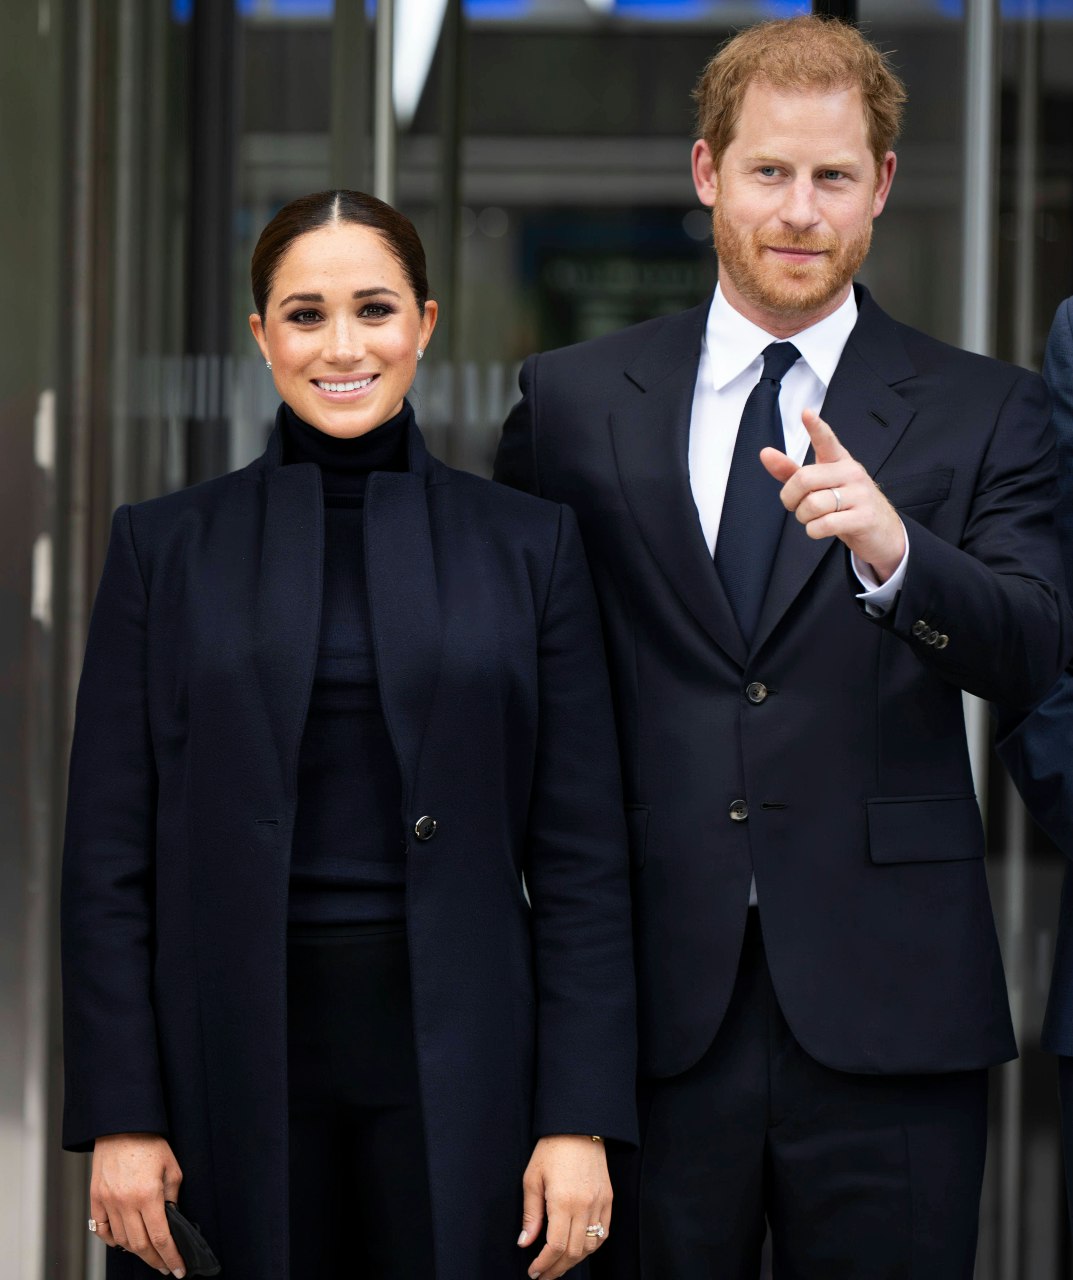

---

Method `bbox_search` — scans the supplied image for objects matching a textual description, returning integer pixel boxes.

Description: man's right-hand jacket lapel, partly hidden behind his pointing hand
[753,285,916,652]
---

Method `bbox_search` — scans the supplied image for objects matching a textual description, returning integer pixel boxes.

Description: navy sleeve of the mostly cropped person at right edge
[991,298,1073,858]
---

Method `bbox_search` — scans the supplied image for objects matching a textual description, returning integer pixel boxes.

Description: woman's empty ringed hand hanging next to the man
[517,1134,611,1280]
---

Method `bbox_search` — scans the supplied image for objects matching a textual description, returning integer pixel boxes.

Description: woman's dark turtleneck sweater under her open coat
[283,403,414,924]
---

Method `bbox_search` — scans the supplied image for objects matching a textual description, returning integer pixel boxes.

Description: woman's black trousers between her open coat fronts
[287,927,434,1280]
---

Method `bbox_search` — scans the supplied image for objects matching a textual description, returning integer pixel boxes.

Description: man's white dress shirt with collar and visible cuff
[689,285,909,906]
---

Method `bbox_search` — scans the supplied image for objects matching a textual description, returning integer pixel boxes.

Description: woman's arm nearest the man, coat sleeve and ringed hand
[519,508,638,1280]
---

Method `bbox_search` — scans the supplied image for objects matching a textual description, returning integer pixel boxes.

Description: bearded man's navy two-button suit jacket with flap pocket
[496,288,1073,1075]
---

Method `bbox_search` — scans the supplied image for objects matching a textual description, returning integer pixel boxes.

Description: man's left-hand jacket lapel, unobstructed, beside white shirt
[611,295,746,666]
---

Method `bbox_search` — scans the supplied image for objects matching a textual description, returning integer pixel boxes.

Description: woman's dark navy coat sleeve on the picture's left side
[60,507,168,1151]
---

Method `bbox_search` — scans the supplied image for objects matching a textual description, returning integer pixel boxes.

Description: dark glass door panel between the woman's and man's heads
[414,22,737,471]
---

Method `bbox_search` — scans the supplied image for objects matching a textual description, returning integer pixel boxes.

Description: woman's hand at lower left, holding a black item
[90,1133,186,1276]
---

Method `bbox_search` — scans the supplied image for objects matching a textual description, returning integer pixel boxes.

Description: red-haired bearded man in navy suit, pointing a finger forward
[496,17,1073,1280]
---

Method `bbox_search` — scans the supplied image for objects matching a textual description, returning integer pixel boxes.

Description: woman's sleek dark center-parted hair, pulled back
[250,191,429,320]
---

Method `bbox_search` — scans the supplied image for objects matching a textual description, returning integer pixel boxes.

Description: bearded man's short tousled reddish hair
[693,15,905,175]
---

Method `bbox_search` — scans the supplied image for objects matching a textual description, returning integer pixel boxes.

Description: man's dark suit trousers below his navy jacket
[593,910,987,1280]
